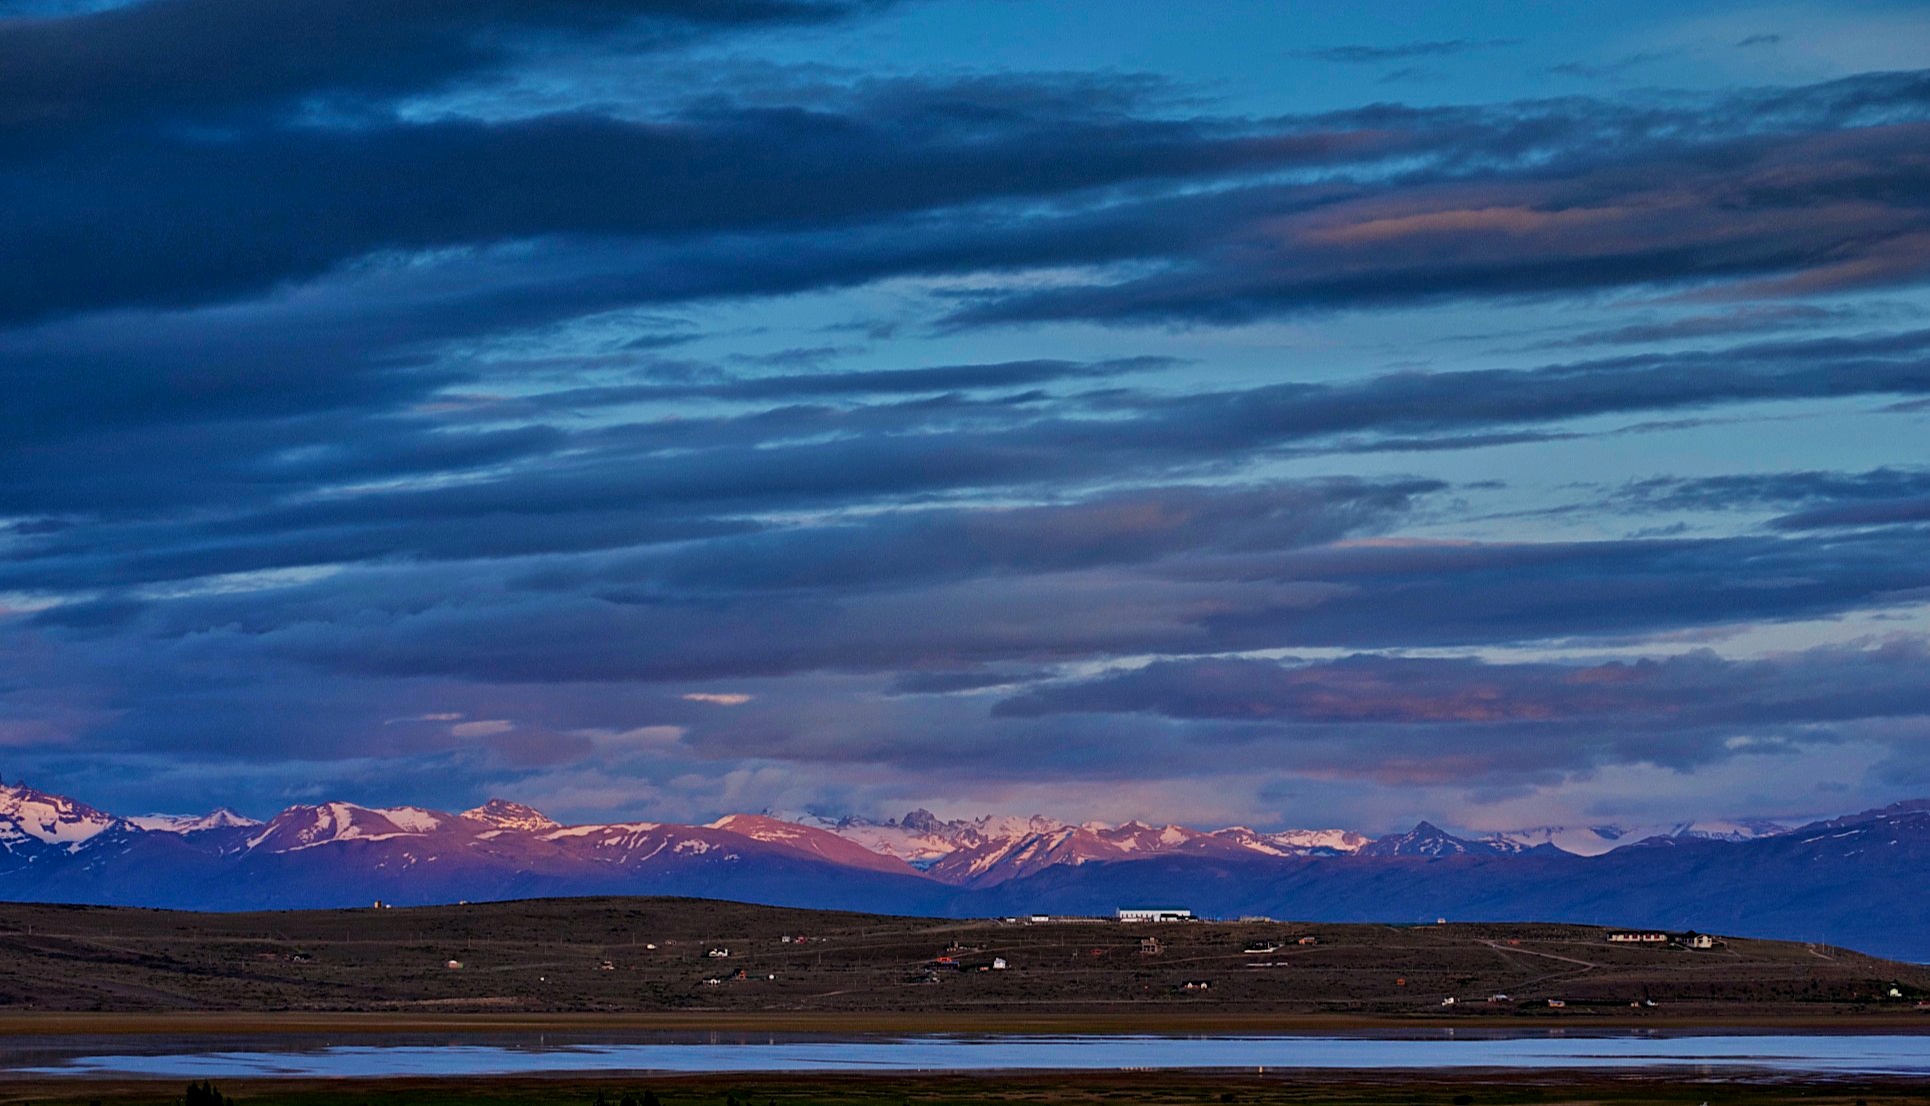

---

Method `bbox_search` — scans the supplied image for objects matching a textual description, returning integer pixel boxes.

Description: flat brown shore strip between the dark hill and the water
[0,1009,1930,1038]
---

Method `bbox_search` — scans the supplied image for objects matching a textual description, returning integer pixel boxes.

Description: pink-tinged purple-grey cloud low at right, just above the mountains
[972,641,1930,782]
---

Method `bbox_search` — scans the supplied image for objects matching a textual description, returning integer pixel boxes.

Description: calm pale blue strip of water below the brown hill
[11,1031,1930,1079]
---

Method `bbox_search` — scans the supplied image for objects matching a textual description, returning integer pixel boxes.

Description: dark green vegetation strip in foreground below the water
[11,1071,1930,1106]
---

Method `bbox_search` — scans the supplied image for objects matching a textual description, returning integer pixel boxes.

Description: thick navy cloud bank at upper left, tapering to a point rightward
[0,83,1389,318]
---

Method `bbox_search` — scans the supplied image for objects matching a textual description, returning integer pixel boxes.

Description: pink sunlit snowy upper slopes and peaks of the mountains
[0,772,1868,901]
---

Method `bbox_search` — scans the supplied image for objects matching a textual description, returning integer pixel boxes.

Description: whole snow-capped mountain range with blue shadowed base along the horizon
[0,784,1930,959]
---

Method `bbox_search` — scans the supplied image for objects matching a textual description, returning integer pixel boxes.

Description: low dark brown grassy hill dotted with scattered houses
[0,898,1930,1019]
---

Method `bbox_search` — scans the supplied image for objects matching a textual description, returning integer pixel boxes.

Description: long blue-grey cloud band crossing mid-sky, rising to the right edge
[0,332,1930,589]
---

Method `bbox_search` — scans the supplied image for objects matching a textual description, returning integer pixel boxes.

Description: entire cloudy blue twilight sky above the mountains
[0,0,1930,830]
